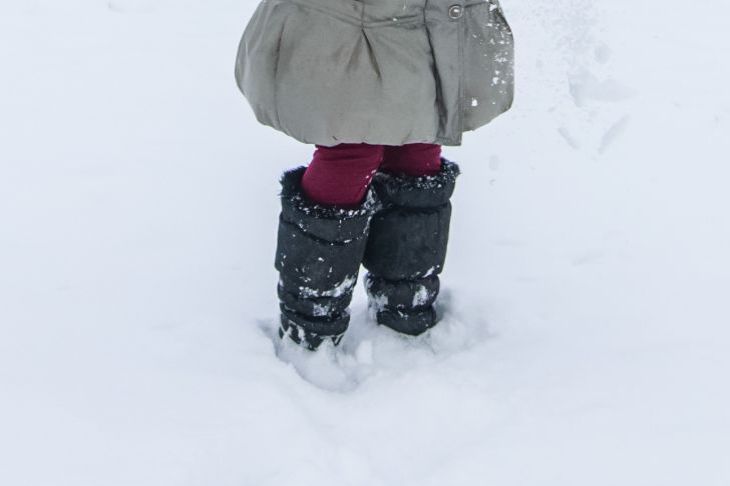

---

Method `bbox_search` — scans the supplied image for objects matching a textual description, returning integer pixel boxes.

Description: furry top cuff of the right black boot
[375,157,461,208]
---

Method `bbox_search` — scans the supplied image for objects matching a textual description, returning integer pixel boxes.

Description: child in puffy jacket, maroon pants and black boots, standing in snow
[236,0,514,350]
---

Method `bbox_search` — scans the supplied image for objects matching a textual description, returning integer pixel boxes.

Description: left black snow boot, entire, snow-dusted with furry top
[276,167,375,350]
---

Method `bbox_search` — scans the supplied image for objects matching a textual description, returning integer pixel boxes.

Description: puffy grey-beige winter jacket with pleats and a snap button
[236,0,514,146]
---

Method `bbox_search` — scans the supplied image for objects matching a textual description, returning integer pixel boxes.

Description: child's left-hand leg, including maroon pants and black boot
[276,144,383,349]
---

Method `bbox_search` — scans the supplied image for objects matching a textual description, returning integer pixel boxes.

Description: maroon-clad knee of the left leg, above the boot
[302,143,383,207]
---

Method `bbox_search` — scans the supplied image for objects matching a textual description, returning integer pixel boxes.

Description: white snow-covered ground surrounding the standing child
[0,0,730,486]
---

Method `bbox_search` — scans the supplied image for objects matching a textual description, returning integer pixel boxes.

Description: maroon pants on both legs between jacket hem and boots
[302,143,441,207]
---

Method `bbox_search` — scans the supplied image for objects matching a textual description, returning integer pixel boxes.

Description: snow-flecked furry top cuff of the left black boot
[281,167,377,243]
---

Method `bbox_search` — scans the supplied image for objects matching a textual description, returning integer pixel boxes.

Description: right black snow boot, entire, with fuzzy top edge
[363,158,459,336]
